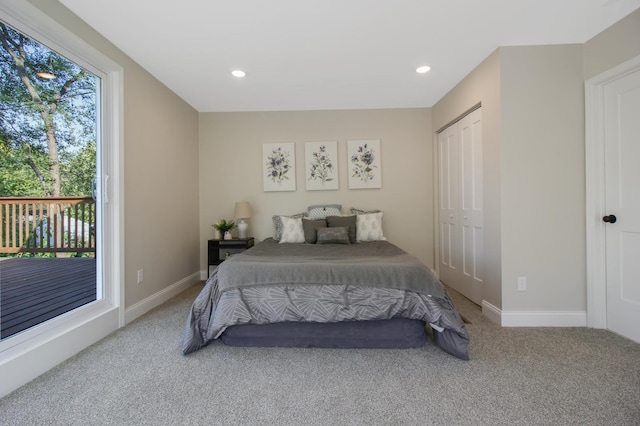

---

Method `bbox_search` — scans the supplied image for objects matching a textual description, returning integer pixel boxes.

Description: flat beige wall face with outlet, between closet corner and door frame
[500,44,586,311]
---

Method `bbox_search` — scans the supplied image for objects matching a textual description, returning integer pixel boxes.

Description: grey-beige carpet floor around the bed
[0,286,640,425]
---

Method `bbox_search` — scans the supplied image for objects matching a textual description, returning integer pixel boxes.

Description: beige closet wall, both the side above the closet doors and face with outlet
[432,45,586,311]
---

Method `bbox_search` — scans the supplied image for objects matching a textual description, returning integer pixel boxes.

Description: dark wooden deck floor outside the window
[0,257,96,339]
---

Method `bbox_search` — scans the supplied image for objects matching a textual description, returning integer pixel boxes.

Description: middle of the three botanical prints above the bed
[304,141,338,191]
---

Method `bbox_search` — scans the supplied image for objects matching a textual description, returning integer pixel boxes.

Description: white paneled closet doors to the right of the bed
[438,109,484,304]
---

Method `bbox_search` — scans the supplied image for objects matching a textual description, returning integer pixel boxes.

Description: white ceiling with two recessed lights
[60,0,640,112]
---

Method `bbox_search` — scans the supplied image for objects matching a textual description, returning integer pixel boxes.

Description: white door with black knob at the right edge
[603,70,640,342]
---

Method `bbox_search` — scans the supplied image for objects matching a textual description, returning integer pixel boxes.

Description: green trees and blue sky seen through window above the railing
[0,22,97,196]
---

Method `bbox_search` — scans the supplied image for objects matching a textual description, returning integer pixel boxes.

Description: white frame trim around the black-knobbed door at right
[585,56,640,328]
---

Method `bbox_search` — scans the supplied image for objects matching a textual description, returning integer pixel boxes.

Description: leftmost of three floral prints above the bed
[262,143,296,191]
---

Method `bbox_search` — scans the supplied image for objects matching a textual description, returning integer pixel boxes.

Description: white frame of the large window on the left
[0,0,125,398]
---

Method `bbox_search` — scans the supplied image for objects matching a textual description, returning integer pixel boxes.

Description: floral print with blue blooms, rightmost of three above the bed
[347,140,382,189]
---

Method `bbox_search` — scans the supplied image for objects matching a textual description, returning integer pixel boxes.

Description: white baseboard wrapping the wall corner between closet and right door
[482,300,587,327]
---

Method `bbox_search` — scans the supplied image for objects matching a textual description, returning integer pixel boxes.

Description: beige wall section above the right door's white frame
[584,9,640,79]
